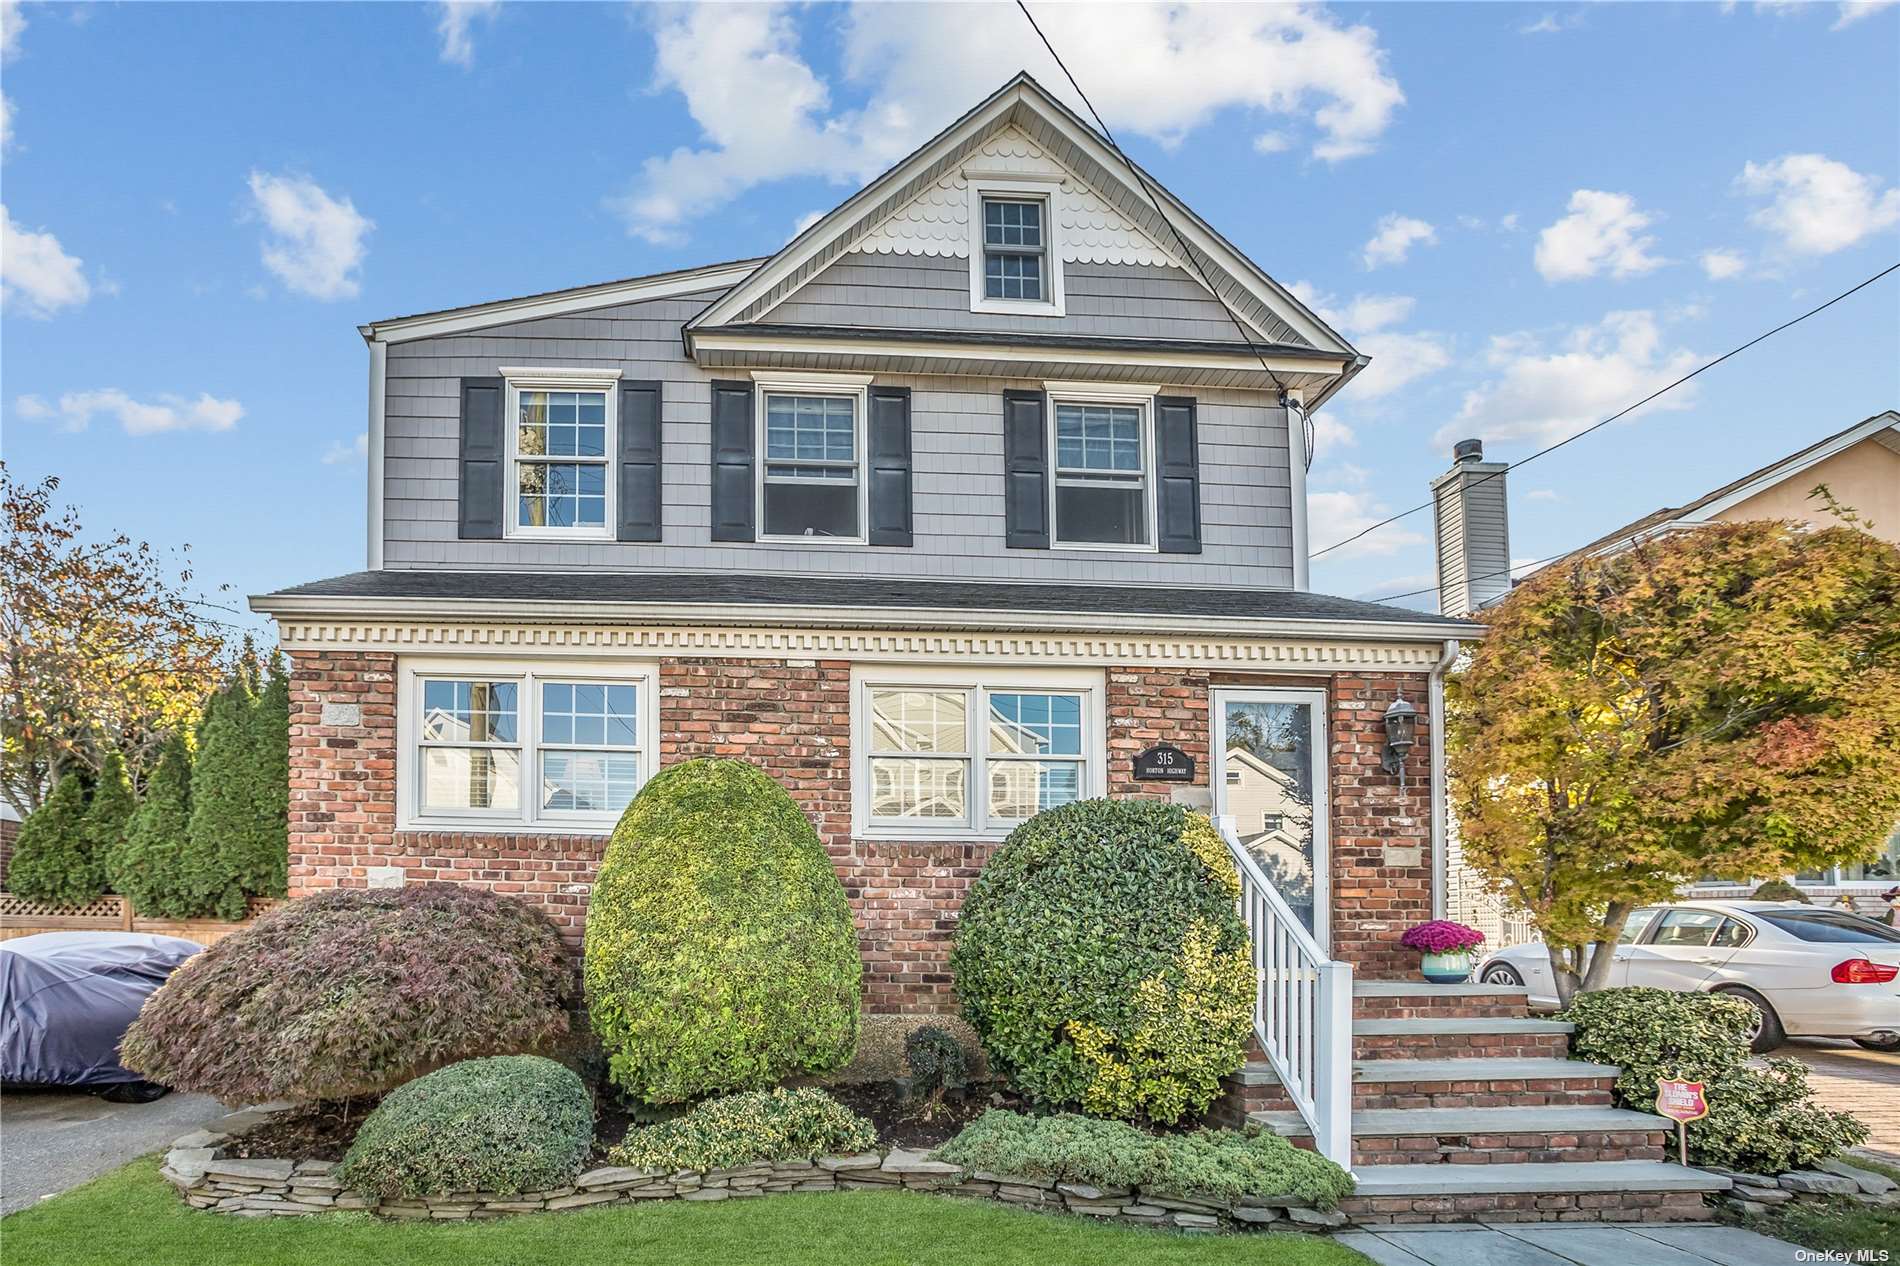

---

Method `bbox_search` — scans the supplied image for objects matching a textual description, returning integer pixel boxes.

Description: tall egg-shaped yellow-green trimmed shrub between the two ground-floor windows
[585,760,863,1104]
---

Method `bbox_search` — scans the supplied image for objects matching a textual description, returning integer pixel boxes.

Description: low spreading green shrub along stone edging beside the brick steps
[935,1108,1353,1209]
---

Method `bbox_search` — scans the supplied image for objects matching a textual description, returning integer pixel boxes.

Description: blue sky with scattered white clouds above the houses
[0,2,1900,631]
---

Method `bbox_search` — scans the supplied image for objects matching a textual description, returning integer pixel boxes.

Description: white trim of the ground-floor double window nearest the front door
[851,663,1108,842]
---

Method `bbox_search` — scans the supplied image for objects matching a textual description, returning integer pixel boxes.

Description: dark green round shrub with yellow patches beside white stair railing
[950,800,1254,1122]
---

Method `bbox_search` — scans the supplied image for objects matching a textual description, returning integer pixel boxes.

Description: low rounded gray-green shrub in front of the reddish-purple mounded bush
[336,1055,593,1199]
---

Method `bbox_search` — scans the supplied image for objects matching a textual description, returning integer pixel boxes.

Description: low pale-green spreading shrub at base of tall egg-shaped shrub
[612,1087,878,1169]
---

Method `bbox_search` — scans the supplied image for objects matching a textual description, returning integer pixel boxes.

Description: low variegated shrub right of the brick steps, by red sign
[1564,987,1866,1173]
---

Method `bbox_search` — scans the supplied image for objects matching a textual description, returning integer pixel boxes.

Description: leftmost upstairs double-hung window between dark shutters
[507,371,618,538]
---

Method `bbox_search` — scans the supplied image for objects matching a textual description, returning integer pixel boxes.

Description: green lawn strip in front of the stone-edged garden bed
[0,1160,1366,1266]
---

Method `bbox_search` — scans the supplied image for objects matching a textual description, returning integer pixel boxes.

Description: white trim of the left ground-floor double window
[395,656,659,834]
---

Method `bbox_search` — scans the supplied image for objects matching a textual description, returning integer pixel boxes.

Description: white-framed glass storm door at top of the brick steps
[1212,690,1330,949]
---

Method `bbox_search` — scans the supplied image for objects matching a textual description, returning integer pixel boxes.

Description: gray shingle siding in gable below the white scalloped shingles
[756,251,1262,342]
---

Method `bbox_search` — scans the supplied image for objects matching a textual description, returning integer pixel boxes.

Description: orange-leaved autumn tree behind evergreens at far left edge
[0,466,226,817]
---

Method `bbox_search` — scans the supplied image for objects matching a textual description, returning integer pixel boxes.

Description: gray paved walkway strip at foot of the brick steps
[1334,1222,1797,1266]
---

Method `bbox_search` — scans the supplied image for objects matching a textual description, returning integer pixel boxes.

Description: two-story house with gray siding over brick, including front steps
[253,76,1725,1220]
